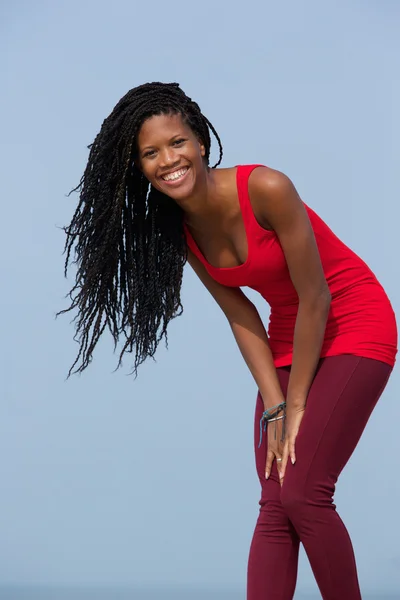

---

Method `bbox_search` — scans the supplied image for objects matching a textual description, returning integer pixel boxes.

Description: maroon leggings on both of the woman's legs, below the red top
[247,355,392,600]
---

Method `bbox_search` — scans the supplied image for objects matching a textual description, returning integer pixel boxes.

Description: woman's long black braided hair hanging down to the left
[58,82,222,376]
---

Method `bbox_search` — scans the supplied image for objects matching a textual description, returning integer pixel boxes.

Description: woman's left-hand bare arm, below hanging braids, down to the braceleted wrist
[188,250,284,409]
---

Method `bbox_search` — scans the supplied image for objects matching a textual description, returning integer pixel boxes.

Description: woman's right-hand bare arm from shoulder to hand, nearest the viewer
[249,167,331,480]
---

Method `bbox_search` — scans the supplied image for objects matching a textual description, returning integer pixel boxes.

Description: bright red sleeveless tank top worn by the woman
[185,165,397,367]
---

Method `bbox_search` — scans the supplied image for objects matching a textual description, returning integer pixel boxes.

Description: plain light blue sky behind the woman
[0,0,400,594]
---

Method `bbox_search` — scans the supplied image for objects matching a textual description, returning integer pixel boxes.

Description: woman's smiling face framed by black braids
[138,115,206,200]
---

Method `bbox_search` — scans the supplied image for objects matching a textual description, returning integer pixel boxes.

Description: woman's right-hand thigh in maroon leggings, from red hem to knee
[284,355,392,490]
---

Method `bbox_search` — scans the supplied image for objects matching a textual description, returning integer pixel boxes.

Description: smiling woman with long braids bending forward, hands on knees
[63,83,397,600]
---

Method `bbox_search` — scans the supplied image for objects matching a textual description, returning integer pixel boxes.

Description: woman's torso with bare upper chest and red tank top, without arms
[186,165,397,367]
